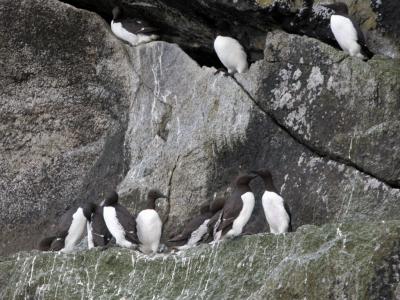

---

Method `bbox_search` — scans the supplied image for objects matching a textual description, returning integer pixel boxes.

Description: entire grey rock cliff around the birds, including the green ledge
[0,0,400,299]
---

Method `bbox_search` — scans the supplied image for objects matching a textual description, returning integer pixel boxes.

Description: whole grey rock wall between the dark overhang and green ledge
[0,0,400,254]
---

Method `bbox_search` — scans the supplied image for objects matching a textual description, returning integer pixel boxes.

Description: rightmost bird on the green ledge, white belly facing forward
[253,169,292,234]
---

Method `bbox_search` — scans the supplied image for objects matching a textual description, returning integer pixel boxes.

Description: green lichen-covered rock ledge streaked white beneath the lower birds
[0,221,400,299]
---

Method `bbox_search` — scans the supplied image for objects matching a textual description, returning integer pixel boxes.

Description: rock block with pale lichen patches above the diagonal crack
[238,32,400,187]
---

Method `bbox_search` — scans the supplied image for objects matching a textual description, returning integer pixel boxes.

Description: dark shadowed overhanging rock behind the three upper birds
[58,0,400,60]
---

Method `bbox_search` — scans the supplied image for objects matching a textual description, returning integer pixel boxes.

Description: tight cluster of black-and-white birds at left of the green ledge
[39,189,168,253]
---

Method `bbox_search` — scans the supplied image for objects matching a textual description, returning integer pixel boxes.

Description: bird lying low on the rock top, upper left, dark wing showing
[111,6,158,46]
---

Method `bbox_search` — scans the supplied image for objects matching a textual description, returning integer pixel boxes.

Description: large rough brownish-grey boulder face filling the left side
[0,0,133,253]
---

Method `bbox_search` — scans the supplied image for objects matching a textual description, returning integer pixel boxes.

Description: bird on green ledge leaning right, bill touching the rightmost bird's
[214,174,257,241]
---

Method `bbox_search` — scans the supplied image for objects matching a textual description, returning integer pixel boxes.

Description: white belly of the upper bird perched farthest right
[330,15,360,55]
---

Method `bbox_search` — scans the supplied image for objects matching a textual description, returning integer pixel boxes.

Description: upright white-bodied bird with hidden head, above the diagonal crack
[214,35,248,75]
